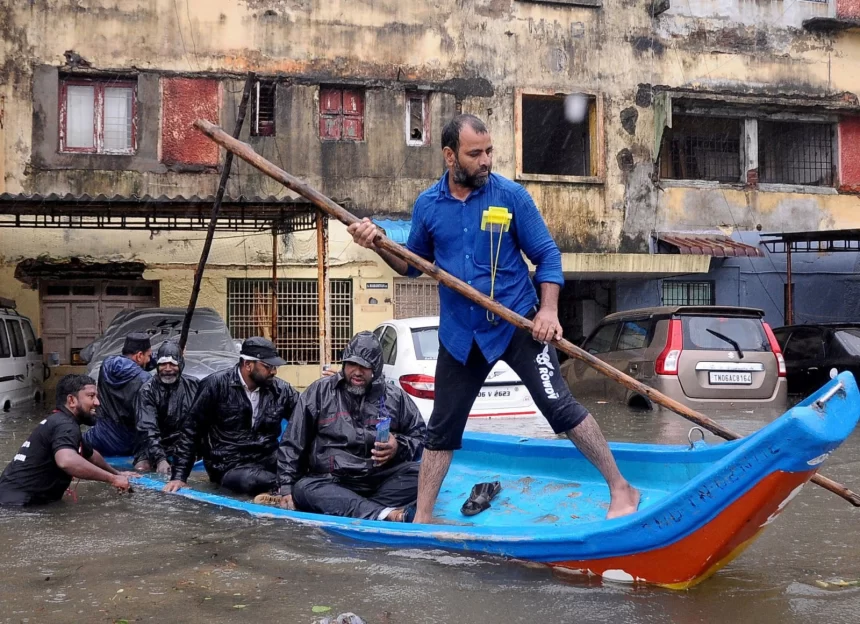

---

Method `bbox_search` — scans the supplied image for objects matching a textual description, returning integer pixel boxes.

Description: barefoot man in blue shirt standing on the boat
[349,115,639,522]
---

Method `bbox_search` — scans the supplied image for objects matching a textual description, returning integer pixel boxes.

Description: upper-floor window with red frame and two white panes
[60,80,137,154]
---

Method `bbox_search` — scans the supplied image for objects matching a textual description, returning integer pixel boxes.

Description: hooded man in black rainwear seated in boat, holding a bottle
[254,332,425,522]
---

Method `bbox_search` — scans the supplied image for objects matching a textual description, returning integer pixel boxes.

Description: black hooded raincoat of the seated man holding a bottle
[278,332,425,496]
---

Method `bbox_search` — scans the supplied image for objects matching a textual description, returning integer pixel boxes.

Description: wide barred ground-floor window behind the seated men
[227,279,352,364]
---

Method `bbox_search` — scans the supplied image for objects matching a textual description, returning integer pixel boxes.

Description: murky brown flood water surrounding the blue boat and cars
[0,404,860,624]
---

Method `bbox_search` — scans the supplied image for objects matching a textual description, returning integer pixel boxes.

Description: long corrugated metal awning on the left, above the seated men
[0,193,346,234]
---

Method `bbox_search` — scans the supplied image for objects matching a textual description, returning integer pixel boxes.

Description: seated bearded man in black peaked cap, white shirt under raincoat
[164,337,299,496]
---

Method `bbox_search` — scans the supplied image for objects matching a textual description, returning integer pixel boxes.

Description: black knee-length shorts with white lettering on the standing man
[424,329,588,451]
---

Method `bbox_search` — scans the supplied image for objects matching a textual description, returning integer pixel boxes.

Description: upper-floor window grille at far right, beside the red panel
[758,121,833,186]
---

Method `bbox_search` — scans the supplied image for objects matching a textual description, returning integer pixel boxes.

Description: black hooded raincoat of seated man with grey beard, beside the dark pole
[135,341,199,470]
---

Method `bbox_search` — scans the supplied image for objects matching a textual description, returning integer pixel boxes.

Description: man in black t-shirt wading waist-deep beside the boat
[0,375,130,505]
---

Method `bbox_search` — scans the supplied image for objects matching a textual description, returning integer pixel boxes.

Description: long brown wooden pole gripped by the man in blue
[195,119,860,507]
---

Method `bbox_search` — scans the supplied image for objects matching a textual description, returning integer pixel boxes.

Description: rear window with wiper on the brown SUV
[682,316,770,351]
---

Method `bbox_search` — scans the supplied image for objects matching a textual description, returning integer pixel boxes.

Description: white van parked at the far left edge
[0,297,47,411]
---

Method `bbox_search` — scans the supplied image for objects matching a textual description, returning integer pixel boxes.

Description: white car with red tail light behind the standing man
[373,316,538,421]
